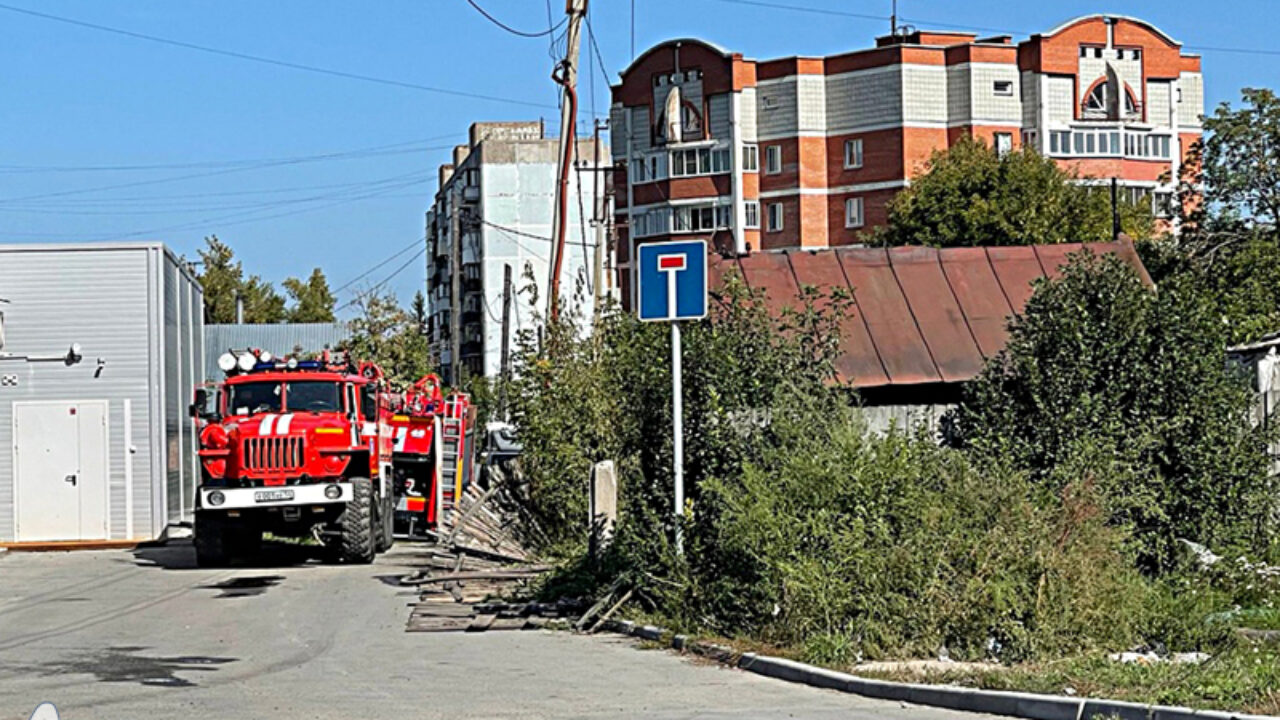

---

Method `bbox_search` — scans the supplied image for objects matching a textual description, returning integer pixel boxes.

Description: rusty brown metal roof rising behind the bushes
[710,240,1151,388]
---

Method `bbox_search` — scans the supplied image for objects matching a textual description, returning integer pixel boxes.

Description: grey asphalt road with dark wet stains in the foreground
[0,542,980,720]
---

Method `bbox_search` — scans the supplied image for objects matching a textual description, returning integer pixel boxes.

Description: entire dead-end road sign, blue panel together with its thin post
[636,240,707,553]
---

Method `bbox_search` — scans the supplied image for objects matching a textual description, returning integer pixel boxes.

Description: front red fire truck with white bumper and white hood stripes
[192,350,394,566]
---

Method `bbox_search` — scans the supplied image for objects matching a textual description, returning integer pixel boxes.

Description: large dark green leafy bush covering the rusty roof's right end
[956,252,1274,568]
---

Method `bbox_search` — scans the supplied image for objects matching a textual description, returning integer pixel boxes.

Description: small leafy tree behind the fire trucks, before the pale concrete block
[347,292,433,386]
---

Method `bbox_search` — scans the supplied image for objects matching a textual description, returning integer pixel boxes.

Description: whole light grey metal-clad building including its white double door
[0,242,204,544]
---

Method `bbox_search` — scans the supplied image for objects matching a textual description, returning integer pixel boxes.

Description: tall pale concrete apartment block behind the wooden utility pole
[426,122,612,380]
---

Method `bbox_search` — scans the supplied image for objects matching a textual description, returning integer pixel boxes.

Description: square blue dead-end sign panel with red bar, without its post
[636,240,707,322]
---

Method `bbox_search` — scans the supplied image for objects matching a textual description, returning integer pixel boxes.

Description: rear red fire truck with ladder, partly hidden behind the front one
[390,374,475,537]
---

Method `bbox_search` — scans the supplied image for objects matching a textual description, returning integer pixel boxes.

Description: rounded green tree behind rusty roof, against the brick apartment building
[870,138,1152,247]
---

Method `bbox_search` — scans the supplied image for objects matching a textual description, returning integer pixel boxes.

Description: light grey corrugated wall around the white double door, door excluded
[0,243,204,542]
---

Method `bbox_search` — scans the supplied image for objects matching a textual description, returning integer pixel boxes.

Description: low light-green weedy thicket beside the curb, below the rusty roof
[680,410,1162,662]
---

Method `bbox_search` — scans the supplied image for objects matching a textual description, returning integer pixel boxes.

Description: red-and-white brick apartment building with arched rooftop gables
[611,14,1204,300]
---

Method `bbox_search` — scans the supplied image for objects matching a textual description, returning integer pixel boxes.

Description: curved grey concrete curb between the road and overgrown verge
[593,620,1275,720]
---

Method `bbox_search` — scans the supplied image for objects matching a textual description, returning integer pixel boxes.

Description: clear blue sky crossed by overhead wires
[0,0,1280,311]
